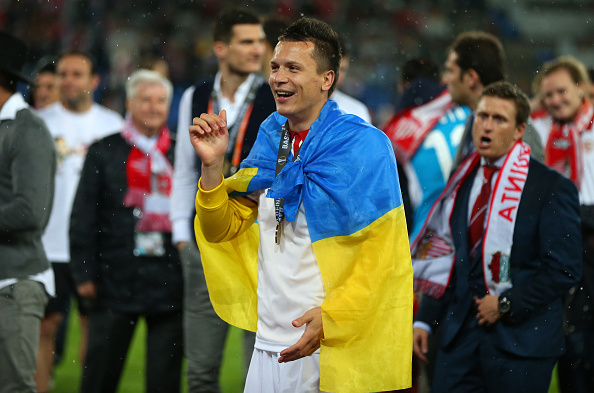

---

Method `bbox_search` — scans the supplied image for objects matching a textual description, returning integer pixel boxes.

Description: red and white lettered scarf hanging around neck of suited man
[411,141,530,298]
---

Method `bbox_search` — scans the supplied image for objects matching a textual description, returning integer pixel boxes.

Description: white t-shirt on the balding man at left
[38,102,123,262]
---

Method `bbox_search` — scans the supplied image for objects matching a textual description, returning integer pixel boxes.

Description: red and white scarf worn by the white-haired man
[121,115,173,232]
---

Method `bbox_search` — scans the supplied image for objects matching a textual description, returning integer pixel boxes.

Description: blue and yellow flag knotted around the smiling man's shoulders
[195,101,413,392]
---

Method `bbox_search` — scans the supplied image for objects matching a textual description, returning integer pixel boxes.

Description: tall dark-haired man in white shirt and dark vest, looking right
[171,8,276,393]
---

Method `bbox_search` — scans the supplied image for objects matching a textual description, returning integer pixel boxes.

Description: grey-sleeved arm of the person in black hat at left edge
[0,116,56,232]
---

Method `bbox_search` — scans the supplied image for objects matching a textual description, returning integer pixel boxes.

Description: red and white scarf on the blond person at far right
[545,99,594,189]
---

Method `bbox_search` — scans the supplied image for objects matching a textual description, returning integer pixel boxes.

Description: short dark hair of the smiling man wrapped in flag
[278,18,342,96]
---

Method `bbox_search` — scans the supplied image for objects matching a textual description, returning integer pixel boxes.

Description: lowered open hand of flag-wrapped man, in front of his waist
[278,307,324,363]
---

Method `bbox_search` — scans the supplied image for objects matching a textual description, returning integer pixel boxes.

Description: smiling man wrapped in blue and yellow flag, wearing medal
[190,18,413,393]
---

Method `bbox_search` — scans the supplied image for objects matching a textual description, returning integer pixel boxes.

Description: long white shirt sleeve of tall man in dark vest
[169,86,198,244]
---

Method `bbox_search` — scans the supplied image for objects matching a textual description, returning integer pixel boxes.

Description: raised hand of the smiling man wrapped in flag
[189,110,229,167]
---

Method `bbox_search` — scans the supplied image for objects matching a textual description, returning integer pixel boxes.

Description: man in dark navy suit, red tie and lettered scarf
[413,82,581,393]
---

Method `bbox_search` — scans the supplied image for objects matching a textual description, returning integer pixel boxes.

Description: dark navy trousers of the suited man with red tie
[432,314,556,393]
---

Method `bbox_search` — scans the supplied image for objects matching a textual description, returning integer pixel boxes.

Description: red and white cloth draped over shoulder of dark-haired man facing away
[384,91,454,162]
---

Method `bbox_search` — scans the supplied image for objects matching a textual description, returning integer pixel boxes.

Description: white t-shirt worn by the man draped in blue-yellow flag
[251,191,326,352]
